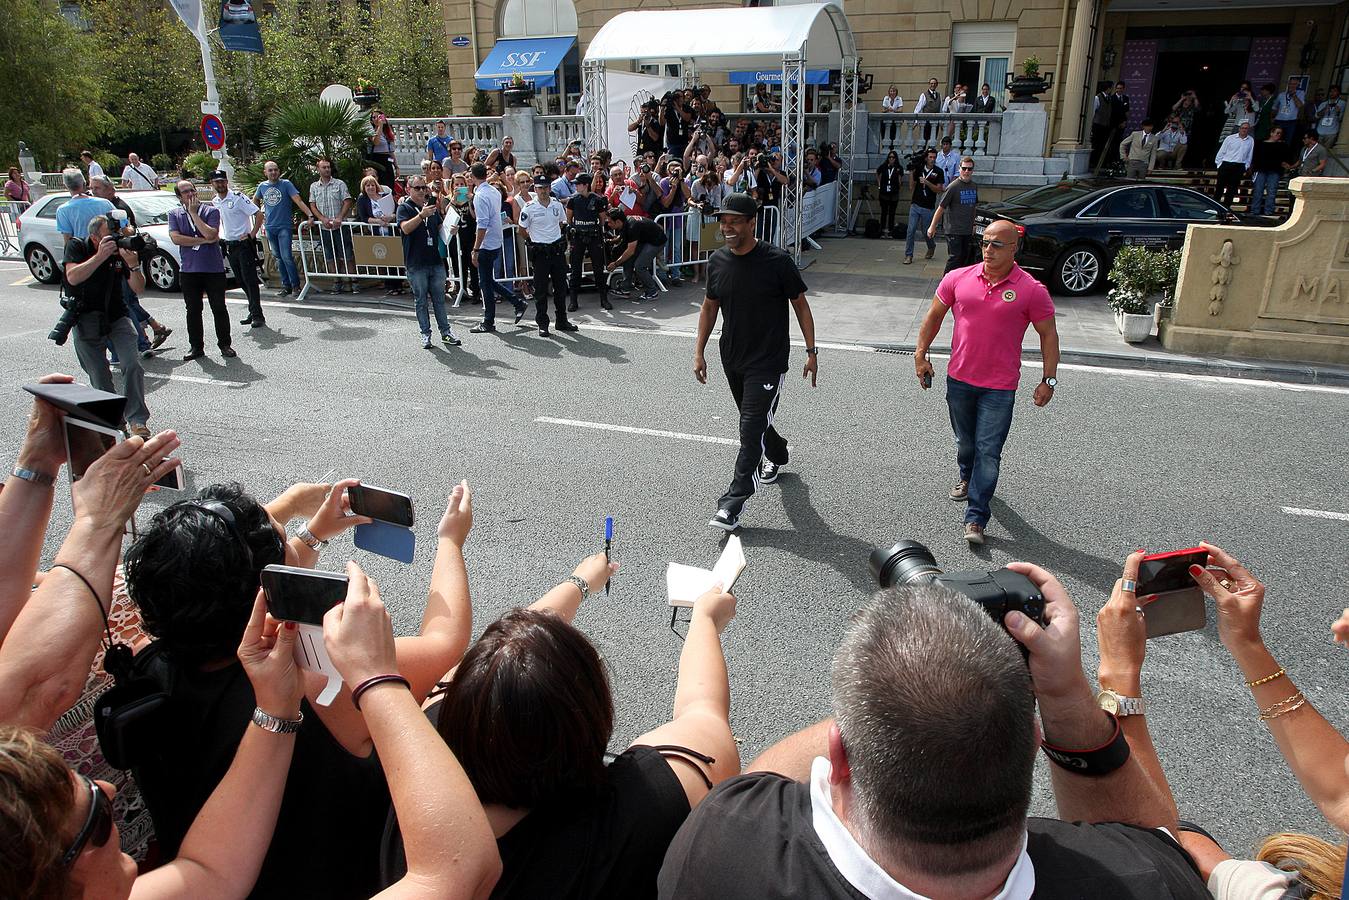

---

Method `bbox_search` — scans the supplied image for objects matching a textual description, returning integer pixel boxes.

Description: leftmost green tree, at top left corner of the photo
[0,0,108,169]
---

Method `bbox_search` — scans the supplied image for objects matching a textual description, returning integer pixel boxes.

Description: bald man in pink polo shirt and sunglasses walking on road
[913,220,1059,544]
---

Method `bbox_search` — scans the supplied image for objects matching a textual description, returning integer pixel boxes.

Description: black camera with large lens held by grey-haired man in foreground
[867,541,1047,627]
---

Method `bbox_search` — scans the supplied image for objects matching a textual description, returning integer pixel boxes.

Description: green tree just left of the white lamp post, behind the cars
[79,0,199,152]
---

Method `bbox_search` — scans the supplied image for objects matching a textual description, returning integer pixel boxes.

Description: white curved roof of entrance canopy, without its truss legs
[585,3,857,72]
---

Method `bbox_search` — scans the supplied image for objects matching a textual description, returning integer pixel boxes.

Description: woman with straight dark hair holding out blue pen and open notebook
[383,553,741,900]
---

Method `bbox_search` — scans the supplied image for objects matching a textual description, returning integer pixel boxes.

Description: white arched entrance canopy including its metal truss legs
[581,3,858,256]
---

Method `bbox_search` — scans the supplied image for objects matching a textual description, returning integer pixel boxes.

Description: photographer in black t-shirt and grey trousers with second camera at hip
[59,215,150,440]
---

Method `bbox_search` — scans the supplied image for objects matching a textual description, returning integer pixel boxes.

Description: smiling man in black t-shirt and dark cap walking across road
[693,193,816,532]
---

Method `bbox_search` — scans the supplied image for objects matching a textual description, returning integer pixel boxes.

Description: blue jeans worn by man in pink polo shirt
[946,375,1016,525]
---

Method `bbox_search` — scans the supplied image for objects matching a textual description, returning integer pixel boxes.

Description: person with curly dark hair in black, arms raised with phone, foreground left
[118,479,472,897]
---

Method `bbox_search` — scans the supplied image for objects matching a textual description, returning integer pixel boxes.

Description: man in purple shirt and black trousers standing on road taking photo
[169,179,239,362]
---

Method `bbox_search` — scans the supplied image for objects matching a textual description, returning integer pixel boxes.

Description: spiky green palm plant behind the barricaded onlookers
[240,100,371,197]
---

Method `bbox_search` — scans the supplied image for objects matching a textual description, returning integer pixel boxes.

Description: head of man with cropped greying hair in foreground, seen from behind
[832,584,1039,876]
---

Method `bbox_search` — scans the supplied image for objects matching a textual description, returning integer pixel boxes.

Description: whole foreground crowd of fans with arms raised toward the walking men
[0,375,1349,900]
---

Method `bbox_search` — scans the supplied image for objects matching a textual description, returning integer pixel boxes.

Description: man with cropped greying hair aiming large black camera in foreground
[658,574,1209,900]
